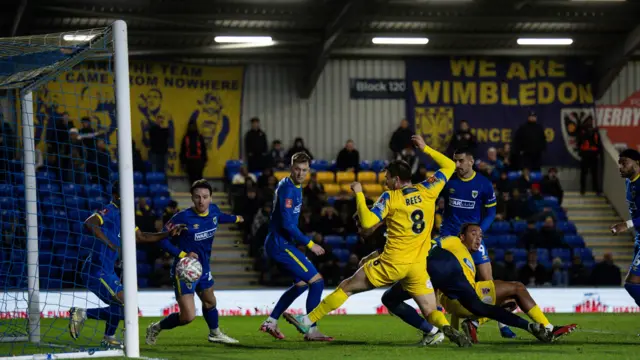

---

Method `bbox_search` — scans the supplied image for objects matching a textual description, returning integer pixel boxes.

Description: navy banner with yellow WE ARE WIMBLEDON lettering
[406,58,594,165]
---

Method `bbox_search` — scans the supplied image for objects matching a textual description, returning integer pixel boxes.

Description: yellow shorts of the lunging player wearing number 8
[364,258,433,296]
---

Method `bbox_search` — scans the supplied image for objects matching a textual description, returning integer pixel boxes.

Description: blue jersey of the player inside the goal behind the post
[85,203,121,272]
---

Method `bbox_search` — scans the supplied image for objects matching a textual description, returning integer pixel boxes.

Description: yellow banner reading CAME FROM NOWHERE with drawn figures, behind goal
[35,62,244,178]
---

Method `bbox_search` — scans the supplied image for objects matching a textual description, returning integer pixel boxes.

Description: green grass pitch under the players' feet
[0,314,640,360]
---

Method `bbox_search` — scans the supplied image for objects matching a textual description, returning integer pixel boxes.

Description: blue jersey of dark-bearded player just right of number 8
[440,173,496,236]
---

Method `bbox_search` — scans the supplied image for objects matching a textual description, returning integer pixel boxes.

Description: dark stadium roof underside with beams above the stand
[0,0,640,98]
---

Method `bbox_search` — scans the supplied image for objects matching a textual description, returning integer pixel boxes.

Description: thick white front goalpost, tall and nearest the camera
[113,20,140,358]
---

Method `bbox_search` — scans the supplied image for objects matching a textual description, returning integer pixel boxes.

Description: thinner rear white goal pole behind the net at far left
[20,91,40,343]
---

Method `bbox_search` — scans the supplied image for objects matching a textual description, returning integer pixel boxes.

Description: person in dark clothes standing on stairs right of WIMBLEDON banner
[576,118,602,195]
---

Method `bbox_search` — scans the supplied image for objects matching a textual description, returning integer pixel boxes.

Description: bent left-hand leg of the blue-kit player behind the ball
[145,276,198,345]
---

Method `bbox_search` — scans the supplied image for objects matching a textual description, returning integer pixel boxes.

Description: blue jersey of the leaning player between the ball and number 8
[267,177,309,245]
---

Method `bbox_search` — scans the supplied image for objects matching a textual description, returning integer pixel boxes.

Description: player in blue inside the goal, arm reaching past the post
[69,181,185,347]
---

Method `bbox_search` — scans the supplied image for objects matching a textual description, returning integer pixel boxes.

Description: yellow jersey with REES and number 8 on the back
[371,171,447,264]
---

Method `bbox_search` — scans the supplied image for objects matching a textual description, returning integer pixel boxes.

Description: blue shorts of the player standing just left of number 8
[264,234,318,283]
